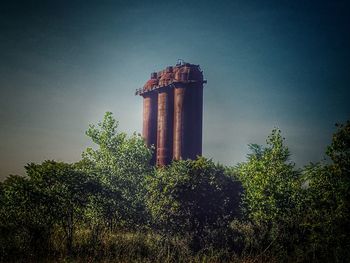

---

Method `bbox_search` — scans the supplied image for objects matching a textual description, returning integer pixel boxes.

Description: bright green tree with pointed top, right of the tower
[238,129,298,223]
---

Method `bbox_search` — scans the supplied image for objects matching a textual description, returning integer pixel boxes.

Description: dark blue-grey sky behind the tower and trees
[0,0,350,178]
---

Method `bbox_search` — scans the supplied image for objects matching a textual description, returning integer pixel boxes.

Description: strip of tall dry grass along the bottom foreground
[1,228,273,263]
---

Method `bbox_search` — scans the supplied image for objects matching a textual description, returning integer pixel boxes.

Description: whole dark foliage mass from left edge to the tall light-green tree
[1,161,96,258]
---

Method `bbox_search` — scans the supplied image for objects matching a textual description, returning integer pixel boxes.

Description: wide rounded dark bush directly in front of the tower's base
[147,157,241,251]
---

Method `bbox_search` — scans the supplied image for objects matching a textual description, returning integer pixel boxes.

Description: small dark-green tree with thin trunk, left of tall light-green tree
[25,161,100,253]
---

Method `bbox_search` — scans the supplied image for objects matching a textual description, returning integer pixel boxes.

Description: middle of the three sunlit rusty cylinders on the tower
[157,91,169,166]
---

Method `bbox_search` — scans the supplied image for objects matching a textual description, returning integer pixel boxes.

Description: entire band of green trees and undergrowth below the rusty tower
[0,113,350,262]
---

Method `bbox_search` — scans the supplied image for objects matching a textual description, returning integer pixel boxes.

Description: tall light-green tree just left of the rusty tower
[82,112,153,228]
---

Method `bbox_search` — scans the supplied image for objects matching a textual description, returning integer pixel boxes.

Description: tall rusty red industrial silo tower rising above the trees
[136,60,206,166]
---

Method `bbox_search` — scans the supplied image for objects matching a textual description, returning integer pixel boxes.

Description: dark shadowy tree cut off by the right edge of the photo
[301,121,350,262]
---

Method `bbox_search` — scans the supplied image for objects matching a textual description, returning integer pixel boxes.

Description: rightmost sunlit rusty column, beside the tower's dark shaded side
[173,87,185,160]
